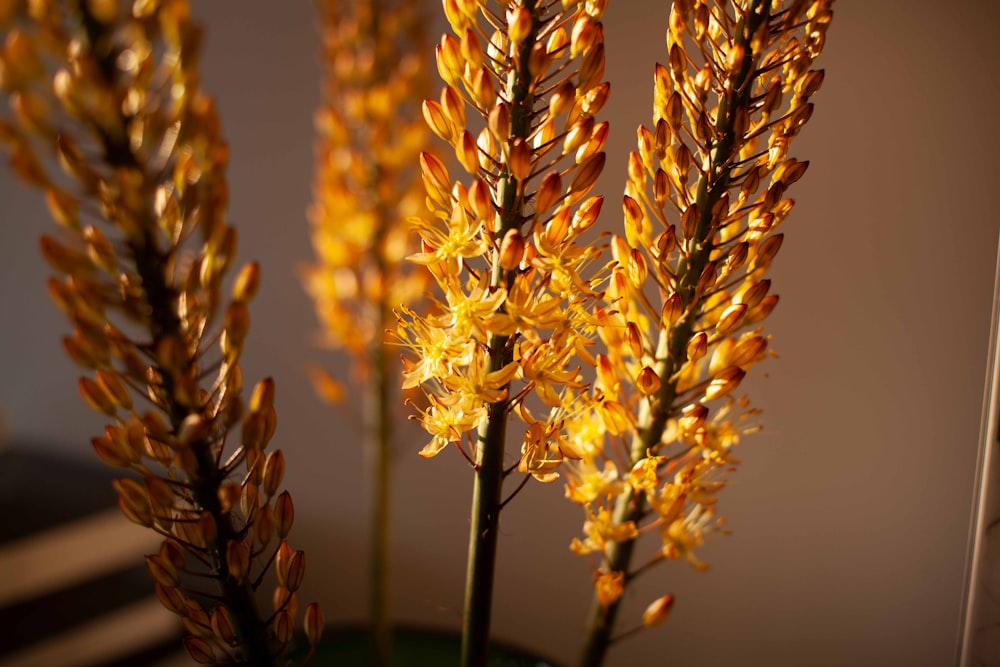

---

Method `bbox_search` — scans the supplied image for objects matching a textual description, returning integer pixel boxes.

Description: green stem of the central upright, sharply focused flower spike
[460,5,539,667]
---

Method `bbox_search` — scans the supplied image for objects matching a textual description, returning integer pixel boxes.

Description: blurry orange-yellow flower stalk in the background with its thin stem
[304,0,429,666]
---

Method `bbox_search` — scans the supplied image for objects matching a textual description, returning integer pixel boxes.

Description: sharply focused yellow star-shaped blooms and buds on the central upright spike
[399,0,609,481]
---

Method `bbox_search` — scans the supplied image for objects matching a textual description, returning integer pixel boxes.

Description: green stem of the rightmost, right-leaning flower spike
[579,0,770,667]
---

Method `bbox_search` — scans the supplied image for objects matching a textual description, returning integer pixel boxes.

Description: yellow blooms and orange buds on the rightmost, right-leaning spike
[566,0,831,656]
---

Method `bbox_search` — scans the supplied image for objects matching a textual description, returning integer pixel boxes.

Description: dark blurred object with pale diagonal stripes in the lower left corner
[0,444,180,667]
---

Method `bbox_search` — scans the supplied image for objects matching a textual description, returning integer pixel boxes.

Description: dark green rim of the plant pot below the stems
[293,626,557,667]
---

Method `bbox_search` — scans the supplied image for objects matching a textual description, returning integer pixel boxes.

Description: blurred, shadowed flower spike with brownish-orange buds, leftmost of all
[0,0,322,665]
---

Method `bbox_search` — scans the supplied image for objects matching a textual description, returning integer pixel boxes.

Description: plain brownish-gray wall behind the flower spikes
[0,0,1000,666]
